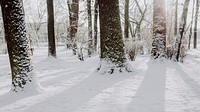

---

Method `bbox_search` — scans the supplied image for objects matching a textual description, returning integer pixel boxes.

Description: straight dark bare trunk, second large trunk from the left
[47,0,56,57]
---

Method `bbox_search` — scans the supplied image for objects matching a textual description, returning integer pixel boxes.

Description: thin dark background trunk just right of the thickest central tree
[124,0,129,39]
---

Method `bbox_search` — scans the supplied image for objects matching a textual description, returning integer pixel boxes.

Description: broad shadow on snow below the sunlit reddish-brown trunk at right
[127,60,166,112]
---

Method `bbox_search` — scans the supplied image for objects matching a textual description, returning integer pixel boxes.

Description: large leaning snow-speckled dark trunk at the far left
[0,0,34,92]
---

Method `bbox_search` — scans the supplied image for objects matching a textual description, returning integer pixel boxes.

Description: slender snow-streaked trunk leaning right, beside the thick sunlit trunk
[173,0,190,61]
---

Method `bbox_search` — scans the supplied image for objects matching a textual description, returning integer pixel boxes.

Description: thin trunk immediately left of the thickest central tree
[94,0,99,51]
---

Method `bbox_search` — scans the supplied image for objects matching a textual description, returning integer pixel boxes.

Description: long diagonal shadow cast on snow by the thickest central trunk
[22,74,130,112]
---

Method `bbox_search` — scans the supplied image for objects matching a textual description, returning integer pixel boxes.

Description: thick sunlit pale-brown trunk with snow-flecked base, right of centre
[151,0,166,59]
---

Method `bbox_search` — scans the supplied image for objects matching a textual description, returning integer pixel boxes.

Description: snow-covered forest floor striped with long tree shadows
[0,47,200,112]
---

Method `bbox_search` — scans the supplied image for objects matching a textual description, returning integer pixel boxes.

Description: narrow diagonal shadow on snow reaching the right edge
[174,64,200,99]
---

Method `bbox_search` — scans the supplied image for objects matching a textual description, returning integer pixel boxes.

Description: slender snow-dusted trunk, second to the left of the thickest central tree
[87,0,94,57]
